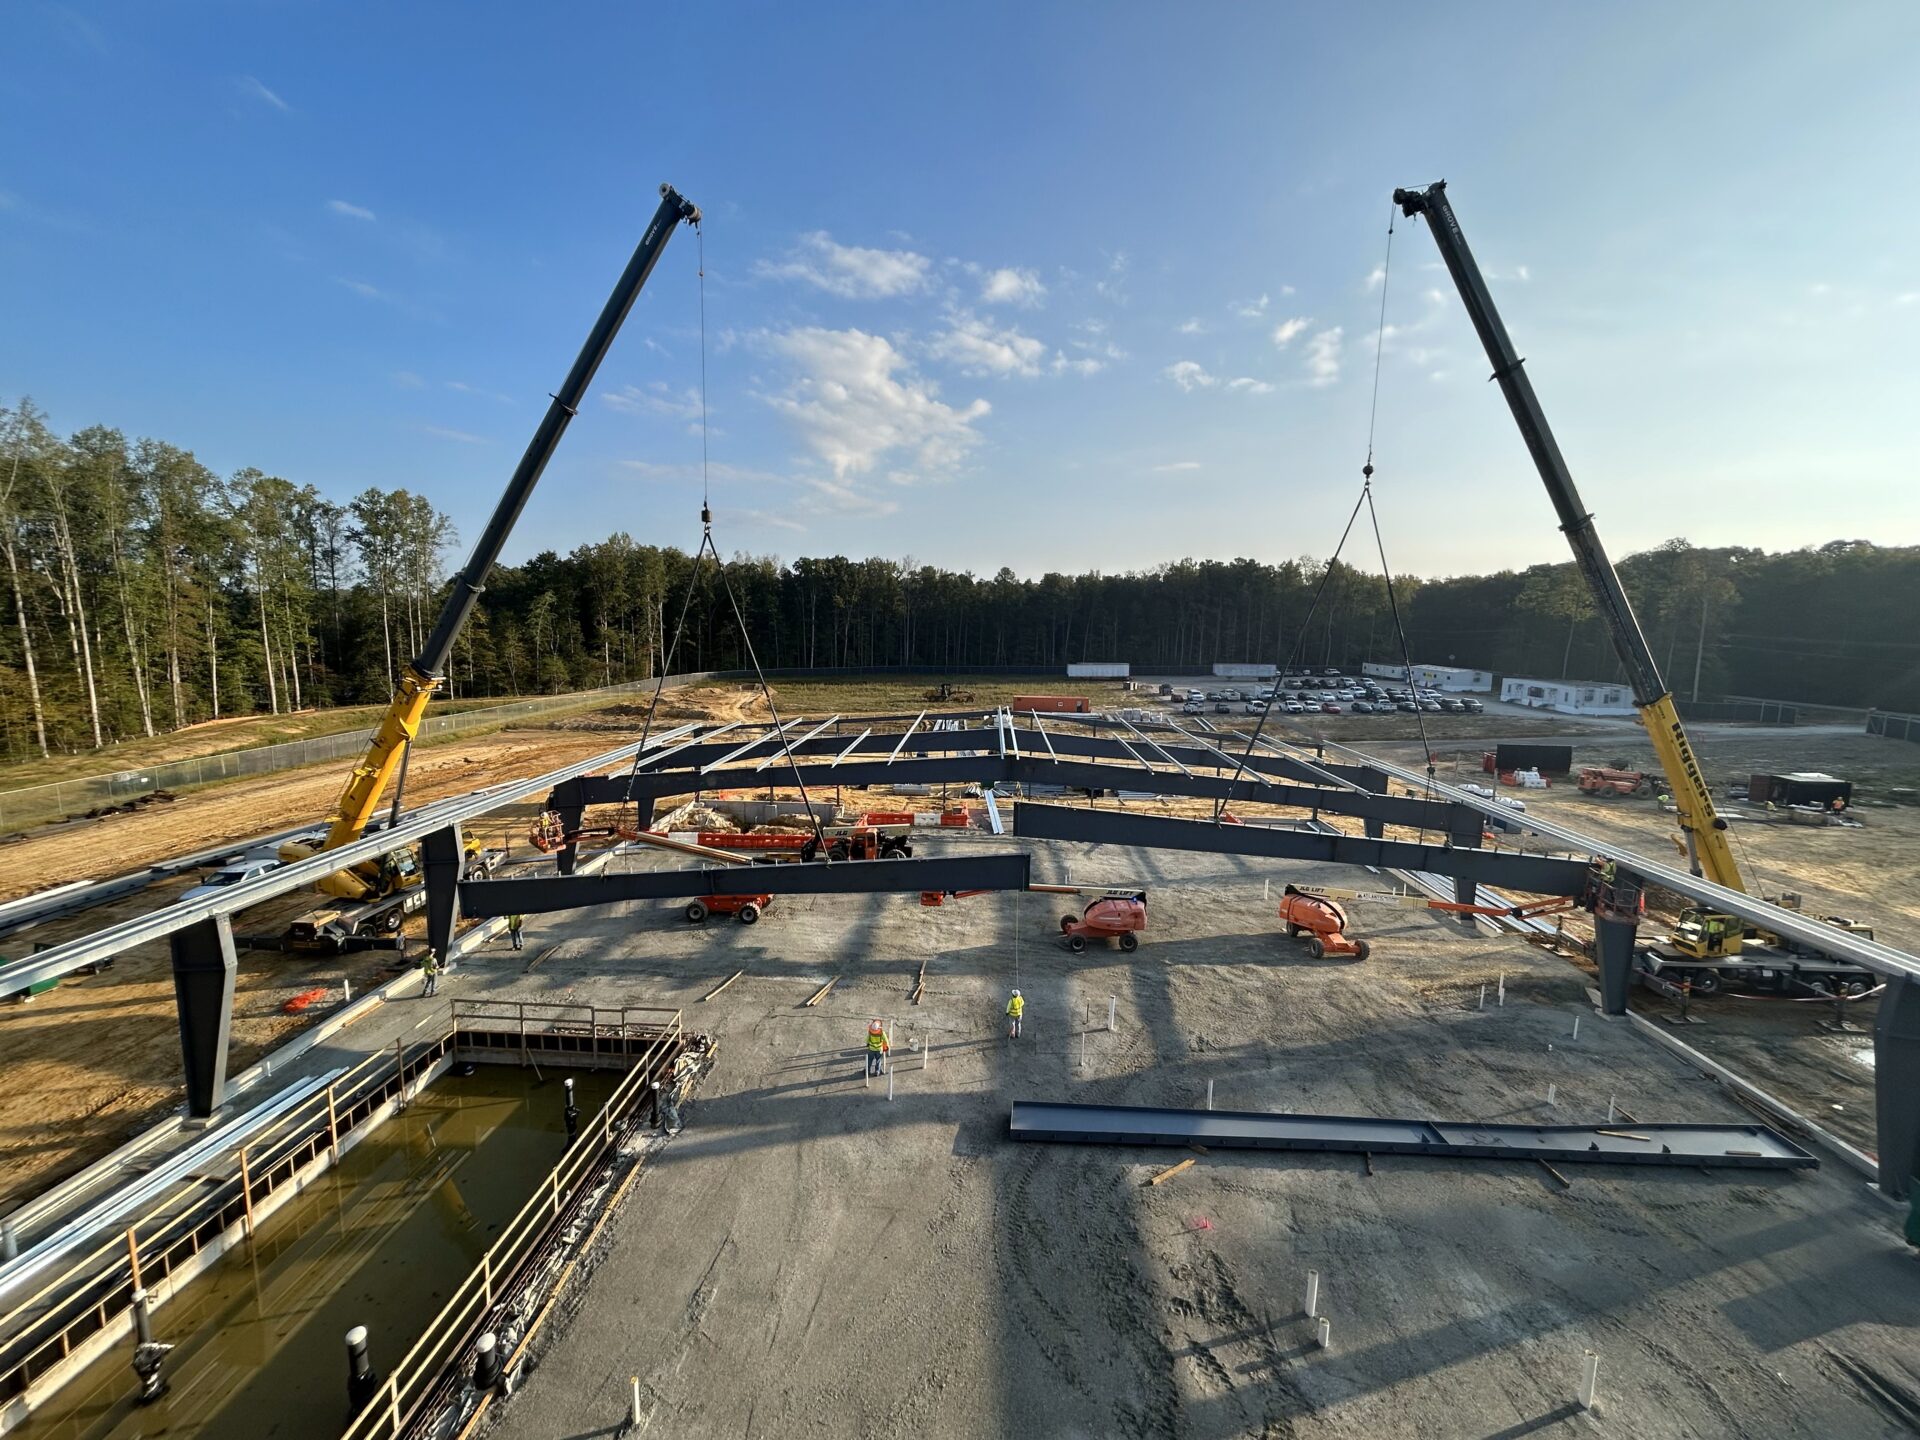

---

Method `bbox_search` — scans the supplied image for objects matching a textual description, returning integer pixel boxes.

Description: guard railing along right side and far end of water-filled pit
[342,1000,684,1440]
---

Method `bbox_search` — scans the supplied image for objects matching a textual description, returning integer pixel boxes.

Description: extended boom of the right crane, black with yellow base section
[1394,180,1745,891]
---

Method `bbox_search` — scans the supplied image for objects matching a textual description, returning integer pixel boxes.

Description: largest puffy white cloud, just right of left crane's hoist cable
[764,326,993,481]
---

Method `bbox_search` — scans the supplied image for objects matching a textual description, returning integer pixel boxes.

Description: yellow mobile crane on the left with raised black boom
[280,184,701,945]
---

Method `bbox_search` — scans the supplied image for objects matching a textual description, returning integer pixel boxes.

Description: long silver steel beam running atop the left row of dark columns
[0,726,732,995]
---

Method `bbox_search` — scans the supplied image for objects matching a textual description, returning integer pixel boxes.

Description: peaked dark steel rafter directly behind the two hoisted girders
[549,753,1451,843]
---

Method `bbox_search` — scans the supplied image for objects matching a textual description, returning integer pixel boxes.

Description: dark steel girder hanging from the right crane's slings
[1014,801,1588,895]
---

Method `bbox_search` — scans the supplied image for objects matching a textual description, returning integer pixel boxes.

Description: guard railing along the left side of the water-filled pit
[0,1027,455,1402]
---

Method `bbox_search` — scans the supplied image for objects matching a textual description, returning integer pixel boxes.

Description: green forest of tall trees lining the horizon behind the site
[0,399,1920,760]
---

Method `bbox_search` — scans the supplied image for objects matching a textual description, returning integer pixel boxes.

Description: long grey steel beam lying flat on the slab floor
[1008,1100,1820,1169]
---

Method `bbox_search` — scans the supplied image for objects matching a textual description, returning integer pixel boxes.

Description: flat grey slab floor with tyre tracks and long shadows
[465,843,1920,1440]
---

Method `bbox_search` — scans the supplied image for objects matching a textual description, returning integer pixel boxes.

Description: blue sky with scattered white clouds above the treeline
[0,0,1920,574]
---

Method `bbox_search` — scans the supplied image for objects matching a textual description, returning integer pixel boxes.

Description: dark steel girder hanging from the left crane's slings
[461,852,1033,918]
